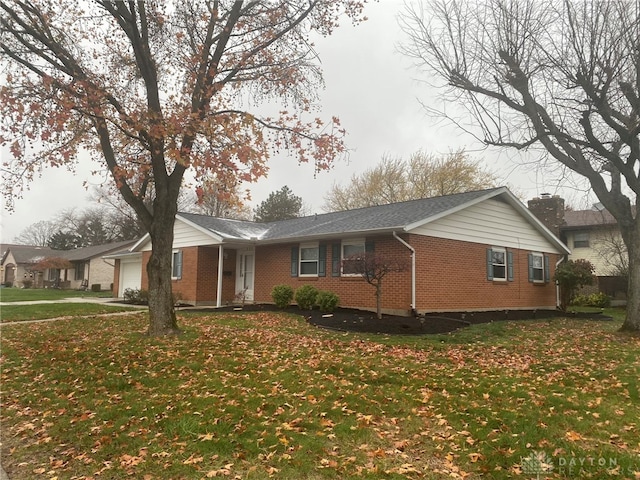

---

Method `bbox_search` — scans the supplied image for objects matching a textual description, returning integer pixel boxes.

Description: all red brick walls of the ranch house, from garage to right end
[135,235,559,313]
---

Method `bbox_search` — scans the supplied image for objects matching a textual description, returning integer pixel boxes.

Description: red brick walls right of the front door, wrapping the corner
[255,235,559,312]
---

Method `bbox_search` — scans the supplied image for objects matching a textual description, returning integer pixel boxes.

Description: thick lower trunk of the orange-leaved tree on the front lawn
[147,206,180,336]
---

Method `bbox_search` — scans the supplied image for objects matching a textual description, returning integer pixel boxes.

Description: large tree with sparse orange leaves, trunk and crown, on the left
[0,0,362,335]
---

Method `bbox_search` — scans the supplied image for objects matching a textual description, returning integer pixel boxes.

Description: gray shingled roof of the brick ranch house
[179,187,504,242]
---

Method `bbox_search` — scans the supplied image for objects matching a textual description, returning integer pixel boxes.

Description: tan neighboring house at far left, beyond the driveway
[2,240,135,290]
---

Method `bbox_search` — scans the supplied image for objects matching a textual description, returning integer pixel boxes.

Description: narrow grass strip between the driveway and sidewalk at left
[0,303,136,323]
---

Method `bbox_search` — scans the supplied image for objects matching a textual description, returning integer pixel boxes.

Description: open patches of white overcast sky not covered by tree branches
[0,0,584,242]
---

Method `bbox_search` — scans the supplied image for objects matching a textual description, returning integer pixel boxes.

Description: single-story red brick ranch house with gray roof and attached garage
[111,187,570,314]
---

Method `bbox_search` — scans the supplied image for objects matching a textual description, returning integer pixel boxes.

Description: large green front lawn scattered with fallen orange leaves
[1,311,640,479]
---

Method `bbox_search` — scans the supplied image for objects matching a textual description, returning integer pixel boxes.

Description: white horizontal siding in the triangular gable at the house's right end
[410,200,563,253]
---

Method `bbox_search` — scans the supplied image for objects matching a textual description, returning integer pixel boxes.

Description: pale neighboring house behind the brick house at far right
[528,194,628,300]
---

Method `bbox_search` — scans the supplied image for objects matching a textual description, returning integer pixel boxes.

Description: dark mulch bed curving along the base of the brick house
[191,304,611,335]
